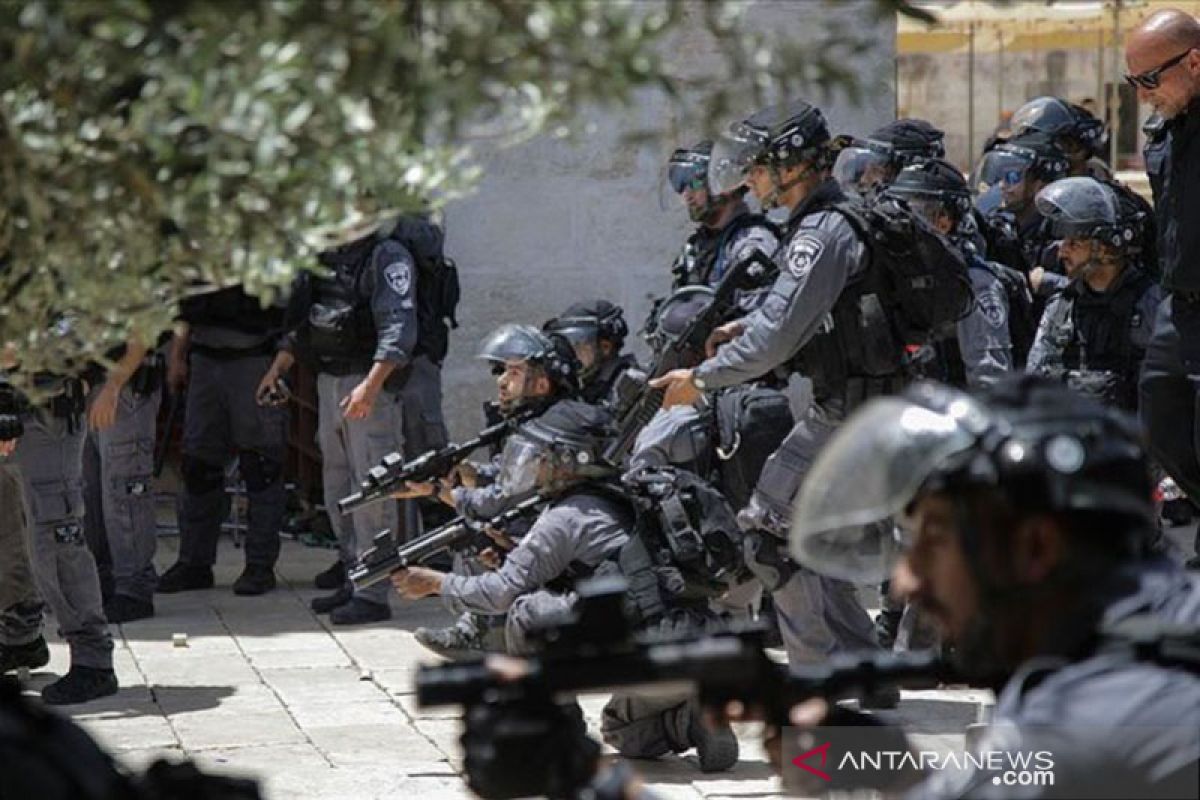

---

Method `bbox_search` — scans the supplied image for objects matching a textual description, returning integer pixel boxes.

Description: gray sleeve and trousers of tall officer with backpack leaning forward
[695,181,878,663]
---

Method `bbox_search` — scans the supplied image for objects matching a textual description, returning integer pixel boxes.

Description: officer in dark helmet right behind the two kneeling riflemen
[541,300,637,404]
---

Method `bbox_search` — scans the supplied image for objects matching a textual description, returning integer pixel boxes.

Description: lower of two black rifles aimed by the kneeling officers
[348,494,546,590]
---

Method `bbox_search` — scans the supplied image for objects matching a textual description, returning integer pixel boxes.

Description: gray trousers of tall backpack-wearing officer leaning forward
[739,402,878,663]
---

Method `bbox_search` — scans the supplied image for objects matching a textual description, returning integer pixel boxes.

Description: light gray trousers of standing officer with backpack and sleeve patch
[317,373,404,603]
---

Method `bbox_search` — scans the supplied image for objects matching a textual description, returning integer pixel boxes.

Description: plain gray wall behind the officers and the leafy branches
[443,0,895,437]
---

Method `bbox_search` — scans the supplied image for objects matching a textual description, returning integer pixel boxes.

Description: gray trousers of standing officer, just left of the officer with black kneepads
[83,385,162,601]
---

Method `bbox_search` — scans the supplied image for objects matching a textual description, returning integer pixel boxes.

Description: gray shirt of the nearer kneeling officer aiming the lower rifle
[442,491,631,654]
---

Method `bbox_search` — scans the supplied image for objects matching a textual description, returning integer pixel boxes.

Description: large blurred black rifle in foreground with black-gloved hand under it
[416,578,952,800]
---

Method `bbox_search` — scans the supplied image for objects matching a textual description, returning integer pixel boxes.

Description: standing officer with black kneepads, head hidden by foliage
[156,287,288,595]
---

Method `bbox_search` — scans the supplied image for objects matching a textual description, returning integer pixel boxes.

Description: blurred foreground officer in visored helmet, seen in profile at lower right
[785,375,1200,798]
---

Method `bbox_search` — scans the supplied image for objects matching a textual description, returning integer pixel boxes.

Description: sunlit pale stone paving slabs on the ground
[30,537,988,800]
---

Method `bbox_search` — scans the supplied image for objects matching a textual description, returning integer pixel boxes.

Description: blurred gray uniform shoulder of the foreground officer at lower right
[911,561,1200,800]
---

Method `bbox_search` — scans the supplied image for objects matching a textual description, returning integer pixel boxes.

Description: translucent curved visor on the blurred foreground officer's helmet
[791,397,976,583]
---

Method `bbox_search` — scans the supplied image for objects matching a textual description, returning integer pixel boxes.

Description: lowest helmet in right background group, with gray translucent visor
[1034,178,1135,249]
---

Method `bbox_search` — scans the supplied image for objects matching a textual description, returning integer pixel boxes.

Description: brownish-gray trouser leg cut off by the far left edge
[0,458,42,644]
